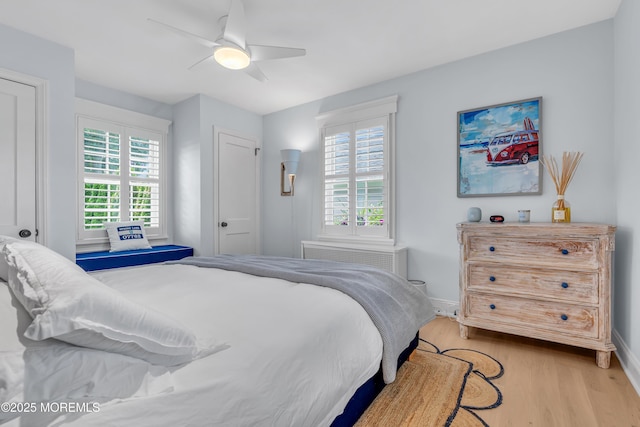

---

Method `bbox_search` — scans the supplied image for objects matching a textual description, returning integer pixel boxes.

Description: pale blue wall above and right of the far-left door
[0,25,76,259]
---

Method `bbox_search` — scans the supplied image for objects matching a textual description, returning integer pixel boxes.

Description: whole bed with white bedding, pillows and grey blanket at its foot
[0,237,435,426]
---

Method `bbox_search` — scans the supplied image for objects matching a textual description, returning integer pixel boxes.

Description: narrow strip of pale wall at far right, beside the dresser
[613,0,640,392]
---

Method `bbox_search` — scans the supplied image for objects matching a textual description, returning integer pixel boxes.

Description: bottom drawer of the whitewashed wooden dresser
[464,292,598,338]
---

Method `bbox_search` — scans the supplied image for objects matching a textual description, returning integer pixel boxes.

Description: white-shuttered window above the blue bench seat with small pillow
[77,100,169,244]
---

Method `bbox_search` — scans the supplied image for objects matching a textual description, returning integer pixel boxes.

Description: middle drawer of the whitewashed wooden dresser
[467,263,598,304]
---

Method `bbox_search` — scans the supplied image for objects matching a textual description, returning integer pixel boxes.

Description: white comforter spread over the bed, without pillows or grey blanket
[0,264,382,427]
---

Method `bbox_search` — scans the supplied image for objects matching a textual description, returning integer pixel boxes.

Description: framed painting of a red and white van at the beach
[458,97,542,197]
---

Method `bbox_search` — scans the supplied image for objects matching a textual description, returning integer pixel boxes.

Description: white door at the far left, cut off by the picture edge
[0,79,37,240]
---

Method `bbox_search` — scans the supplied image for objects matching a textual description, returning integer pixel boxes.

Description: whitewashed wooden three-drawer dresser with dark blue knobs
[457,223,615,368]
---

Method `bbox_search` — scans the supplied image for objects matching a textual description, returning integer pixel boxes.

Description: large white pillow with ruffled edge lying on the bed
[4,241,221,366]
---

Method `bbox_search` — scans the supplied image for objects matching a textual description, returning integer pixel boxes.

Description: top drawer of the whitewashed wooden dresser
[467,236,598,268]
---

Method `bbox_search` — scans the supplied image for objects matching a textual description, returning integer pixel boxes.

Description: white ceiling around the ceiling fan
[0,0,621,114]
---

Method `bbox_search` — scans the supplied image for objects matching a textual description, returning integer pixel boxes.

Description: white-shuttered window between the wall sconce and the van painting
[317,97,397,242]
